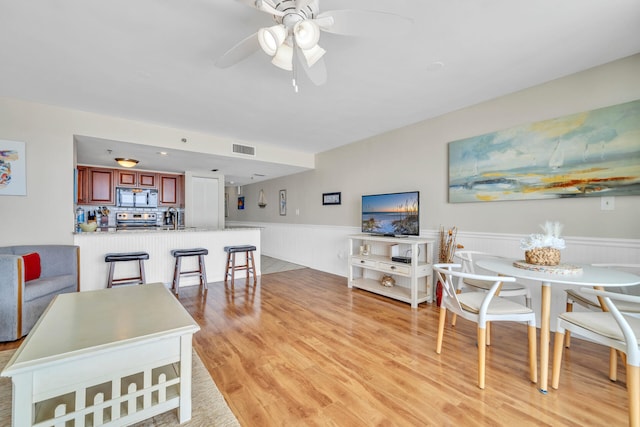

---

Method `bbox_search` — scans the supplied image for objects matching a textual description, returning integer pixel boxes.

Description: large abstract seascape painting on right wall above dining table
[449,100,640,203]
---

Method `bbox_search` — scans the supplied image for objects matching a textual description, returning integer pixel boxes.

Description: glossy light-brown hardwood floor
[0,268,627,426]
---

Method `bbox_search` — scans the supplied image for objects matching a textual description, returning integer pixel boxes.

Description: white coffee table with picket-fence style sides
[1,283,200,427]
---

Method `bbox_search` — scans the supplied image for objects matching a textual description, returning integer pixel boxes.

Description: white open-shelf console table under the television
[348,234,435,308]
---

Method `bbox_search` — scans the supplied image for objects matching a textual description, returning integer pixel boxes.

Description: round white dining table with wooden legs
[476,258,640,393]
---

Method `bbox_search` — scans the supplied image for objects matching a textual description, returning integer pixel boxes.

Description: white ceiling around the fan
[0,0,640,186]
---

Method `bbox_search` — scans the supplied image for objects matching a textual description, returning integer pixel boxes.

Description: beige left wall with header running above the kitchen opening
[0,97,314,246]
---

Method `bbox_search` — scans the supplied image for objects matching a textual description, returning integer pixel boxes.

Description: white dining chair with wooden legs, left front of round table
[433,264,538,389]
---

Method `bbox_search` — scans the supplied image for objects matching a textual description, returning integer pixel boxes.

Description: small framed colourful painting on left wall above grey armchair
[0,139,27,196]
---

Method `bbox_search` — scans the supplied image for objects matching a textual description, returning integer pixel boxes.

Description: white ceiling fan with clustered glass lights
[215,0,412,92]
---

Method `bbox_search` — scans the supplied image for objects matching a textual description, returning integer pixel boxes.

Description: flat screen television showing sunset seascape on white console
[362,191,420,237]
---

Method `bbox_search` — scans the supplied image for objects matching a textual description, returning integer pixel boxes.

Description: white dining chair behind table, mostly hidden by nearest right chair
[564,263,640,381]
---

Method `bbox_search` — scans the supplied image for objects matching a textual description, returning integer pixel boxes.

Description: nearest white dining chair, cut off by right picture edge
[551,288,640,427]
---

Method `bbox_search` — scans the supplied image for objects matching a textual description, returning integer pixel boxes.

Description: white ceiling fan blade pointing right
[315,9,413,37]
